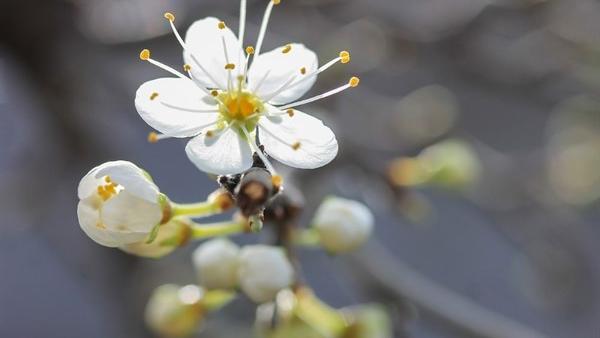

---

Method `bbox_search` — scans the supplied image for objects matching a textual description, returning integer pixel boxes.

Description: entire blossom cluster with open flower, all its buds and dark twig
[77,0,389,338]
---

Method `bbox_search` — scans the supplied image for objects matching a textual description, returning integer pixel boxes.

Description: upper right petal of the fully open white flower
[248,43,319,105]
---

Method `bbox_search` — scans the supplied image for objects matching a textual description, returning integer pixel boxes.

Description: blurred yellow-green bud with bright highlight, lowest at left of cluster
[146,284,204,337]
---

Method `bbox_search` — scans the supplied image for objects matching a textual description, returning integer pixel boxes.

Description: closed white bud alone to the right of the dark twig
[312,197,374,253]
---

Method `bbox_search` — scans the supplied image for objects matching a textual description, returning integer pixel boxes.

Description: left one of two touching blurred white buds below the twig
[192,238,240,289]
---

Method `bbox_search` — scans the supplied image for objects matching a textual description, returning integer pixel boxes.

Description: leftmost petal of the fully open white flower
[135,78,219,137]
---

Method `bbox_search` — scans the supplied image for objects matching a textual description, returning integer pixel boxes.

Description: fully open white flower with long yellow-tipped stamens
[135,0,359,174]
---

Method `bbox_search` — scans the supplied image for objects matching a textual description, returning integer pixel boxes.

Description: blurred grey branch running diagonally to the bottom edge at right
[352,240,546,338]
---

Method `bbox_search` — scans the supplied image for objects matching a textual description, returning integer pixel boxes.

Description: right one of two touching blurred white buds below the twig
[238,245,294,303]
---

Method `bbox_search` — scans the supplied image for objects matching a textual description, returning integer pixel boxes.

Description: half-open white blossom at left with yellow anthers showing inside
[77,161,163,247]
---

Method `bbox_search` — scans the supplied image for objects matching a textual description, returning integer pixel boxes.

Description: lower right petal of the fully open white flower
[258,106,338,169]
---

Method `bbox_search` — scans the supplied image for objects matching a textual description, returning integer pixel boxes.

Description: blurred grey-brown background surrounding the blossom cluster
[0,0,600,338]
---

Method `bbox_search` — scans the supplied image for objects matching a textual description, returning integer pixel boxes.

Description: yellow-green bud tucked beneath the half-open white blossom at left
[119,221,191,258]
